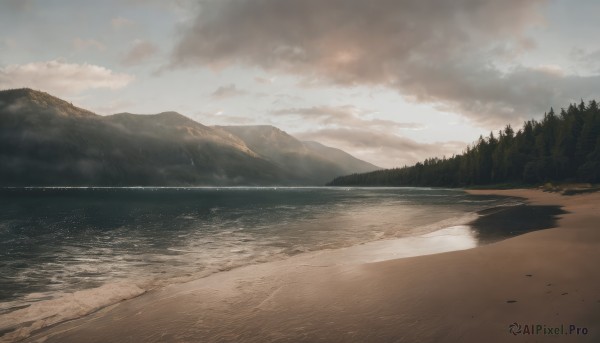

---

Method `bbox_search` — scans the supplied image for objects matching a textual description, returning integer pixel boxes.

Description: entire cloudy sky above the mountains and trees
[0,0,600,168]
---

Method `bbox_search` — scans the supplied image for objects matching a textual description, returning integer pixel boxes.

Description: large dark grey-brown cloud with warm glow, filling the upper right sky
[171,0,600,127]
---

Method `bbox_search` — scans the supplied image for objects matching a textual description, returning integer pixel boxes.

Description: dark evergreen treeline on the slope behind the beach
[328,100,600,187]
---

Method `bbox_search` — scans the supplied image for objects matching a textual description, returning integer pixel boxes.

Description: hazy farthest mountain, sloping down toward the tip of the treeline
[216,125,380,185]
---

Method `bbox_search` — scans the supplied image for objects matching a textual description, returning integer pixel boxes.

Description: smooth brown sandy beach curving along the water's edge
[15,190,600,342]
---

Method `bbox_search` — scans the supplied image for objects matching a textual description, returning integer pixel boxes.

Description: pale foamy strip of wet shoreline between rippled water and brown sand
[0,220,486,343]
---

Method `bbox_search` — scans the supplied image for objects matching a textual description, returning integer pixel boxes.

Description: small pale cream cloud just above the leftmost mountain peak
[0,60,134,95]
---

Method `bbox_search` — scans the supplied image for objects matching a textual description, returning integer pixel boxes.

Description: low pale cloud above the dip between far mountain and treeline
[294,128,466,168]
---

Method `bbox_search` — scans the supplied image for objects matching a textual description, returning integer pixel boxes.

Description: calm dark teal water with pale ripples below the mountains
[0,188,514,314]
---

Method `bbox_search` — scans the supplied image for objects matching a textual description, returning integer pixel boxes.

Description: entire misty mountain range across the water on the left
[0,88,380,186]
